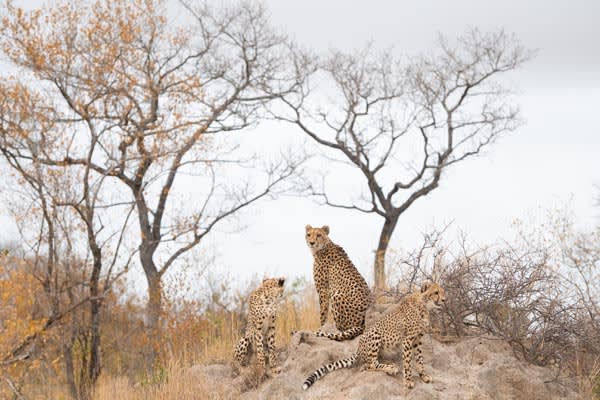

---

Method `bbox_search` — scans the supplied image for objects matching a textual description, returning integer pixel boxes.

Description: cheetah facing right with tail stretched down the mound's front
[302,283,446,390]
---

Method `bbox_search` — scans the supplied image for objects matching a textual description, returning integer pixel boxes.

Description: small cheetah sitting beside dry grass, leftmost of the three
[234,278,285,373]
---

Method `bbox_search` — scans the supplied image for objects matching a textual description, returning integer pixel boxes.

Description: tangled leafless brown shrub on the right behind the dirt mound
[394,218,600,394]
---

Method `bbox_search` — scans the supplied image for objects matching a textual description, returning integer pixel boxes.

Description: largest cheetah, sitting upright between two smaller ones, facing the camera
[306,225,371,340]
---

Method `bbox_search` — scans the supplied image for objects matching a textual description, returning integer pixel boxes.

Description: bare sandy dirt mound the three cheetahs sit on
[190,304,579,400]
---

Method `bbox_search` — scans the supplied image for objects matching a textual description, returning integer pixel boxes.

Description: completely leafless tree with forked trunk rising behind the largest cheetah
[276,30,531,288]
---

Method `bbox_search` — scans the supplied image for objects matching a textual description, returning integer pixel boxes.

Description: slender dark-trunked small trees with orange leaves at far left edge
[0,137,134,399]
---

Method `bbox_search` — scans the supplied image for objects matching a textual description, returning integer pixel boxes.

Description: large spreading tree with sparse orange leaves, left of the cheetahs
[0,0,308,340]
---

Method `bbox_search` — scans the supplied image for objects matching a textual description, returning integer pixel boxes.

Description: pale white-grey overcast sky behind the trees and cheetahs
[0,0,600,294]
